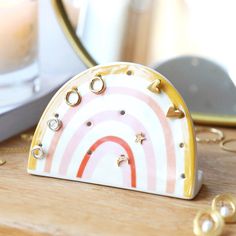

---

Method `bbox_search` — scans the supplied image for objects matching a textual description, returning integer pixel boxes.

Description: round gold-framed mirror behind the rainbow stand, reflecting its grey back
[52,0,236,126]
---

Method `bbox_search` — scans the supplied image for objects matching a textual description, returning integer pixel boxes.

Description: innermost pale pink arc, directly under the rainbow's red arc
[83,142,131,188]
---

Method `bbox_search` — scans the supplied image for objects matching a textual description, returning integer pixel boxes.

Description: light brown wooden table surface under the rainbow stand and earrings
[0,126,236,236]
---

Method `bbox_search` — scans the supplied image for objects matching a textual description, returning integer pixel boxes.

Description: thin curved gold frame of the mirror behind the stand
[51,0,236,127]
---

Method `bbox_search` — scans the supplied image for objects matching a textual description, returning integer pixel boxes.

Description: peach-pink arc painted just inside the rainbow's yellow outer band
[44,87,176,193]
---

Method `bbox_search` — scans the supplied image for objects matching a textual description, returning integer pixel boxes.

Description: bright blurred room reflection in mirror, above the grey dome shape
[63,0,236,83]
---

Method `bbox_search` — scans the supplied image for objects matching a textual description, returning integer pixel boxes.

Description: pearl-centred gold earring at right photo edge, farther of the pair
[211,194,236,223]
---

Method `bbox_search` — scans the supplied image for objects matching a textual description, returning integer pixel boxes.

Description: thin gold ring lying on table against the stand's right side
[195,127,224,143]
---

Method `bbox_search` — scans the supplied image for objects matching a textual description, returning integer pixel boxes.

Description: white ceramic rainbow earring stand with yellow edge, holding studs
[28,63,202,199]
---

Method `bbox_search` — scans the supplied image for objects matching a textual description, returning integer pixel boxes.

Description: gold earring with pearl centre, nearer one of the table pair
[193,210,224,236]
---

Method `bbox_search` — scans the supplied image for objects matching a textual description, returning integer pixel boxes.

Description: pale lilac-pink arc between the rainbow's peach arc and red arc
[59,110,157,191]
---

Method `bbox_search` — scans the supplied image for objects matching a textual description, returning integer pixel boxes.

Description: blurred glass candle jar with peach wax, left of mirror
[0,0,39,106]
